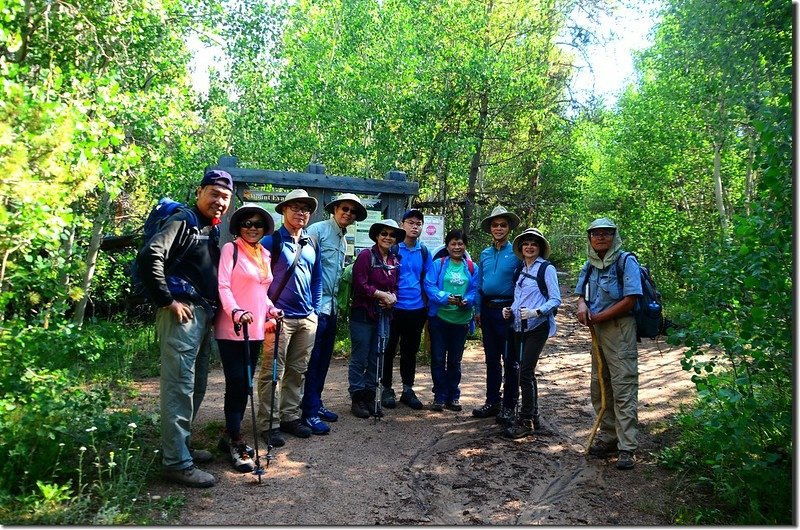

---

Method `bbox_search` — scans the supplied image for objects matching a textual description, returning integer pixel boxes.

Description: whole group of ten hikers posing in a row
[136,170,642,487]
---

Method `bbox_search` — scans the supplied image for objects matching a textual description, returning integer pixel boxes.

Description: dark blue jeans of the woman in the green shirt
[428,317,469,403]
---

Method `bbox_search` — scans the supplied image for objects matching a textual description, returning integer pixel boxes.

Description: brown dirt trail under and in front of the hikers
[138,286,692,525]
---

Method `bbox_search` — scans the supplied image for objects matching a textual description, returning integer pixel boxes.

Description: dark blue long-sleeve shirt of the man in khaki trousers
[261,226,322,318]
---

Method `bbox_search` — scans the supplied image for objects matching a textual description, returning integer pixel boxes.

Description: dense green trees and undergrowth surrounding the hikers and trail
[0,0,794,524]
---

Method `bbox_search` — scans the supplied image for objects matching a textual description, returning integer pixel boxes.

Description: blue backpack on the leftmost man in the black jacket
[128,197,203,304]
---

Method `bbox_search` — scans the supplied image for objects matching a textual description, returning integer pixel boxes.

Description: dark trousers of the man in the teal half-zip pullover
[481,302,518,408]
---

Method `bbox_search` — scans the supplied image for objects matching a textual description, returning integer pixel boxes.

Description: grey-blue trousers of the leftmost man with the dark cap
[156,302,213,470]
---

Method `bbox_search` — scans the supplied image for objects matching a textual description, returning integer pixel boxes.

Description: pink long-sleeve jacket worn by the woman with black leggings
[214,239,275,340]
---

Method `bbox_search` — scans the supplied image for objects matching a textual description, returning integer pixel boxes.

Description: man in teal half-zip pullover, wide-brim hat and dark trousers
[472,202,522,424]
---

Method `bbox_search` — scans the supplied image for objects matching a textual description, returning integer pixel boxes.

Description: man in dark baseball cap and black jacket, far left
[136,170,233,488]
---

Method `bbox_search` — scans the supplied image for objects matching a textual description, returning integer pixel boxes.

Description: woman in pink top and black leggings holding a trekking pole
[214,203,282,473]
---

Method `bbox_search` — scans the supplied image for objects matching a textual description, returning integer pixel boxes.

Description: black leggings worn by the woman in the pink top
[217,339,264,440]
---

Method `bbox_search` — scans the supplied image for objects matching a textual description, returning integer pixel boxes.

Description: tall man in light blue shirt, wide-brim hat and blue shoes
[300,193,367,435]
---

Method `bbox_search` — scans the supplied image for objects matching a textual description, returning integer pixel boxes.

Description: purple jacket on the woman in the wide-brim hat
[353,245,400,320]
